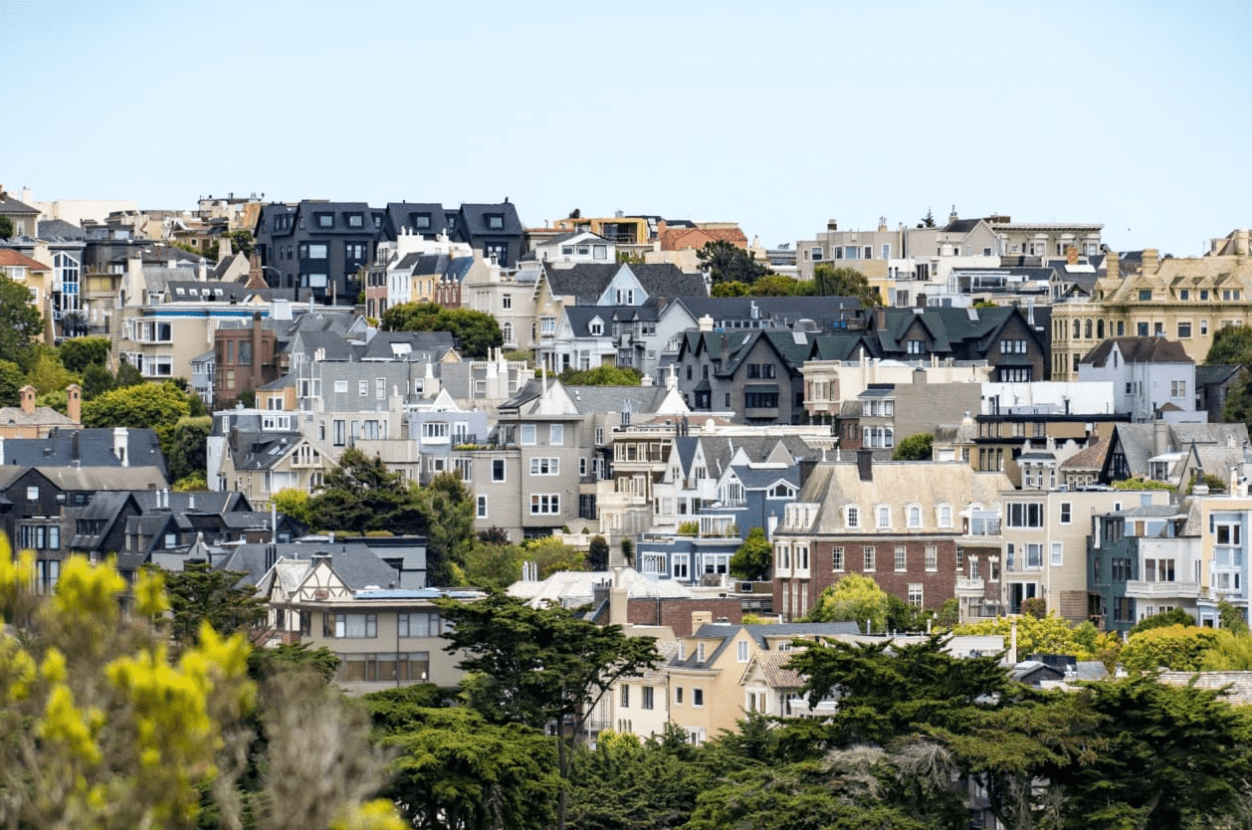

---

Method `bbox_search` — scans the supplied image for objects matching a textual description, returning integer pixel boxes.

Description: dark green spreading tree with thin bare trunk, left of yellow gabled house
[438,591,660,830]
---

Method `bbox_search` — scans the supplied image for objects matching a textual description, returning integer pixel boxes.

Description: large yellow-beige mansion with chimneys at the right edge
[1052,230,1252,381]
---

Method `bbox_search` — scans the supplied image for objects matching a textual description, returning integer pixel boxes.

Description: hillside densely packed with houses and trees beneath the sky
[0,187,1252,827]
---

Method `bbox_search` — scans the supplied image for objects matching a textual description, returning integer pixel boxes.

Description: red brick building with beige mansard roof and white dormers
[774,449,1012,620]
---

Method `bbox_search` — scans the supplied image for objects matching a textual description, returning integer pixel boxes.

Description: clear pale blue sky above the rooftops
[0,0,1252,257]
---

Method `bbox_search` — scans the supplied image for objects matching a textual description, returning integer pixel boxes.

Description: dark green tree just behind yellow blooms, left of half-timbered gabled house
[165,562,265,643]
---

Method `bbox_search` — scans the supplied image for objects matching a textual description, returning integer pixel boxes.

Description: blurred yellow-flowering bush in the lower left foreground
[0,550,402,830]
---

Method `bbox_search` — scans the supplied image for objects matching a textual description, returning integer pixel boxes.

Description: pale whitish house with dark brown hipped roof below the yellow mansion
[1078,337,1207,423]
